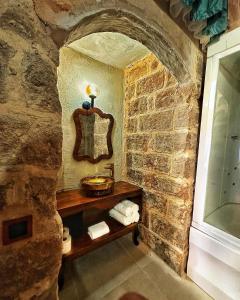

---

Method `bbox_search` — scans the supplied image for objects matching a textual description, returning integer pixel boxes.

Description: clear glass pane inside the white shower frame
[204,52,240,238]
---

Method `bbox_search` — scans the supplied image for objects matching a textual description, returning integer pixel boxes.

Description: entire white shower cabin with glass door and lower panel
[187,28,240,300]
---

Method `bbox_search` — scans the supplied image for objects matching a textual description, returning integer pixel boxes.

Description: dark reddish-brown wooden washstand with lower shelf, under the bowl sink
[57,181,142,286]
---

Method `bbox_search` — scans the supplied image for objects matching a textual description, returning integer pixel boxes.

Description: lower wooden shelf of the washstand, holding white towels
[63,218,138,259]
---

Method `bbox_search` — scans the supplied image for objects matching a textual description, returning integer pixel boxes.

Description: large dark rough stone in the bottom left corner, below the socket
[0,235,62,299]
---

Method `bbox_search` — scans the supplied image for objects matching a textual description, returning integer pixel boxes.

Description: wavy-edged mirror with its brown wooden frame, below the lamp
[73,107,114,164]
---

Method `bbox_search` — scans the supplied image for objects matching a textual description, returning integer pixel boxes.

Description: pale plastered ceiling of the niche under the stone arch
[68,32,150,69]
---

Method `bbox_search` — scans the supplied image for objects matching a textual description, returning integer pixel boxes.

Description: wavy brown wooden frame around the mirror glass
[73,107,114,164]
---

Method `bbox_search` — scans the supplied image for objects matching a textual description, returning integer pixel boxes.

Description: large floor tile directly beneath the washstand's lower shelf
[64,242,138,299]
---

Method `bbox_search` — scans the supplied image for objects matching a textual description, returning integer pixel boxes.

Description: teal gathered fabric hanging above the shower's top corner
[182,0,228,38]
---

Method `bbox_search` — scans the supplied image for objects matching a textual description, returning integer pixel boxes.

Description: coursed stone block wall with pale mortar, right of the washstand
[124,54,200,274]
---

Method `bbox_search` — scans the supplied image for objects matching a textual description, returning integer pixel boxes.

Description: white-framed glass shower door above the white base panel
[193,46,240,243]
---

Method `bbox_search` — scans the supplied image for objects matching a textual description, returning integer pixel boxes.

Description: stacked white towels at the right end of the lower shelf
[109,200,140,226]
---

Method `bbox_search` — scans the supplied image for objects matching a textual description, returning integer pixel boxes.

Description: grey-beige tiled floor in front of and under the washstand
[59,235,211,300]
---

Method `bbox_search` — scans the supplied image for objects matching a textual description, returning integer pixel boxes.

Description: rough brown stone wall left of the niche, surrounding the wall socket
[0,0,62,299]
